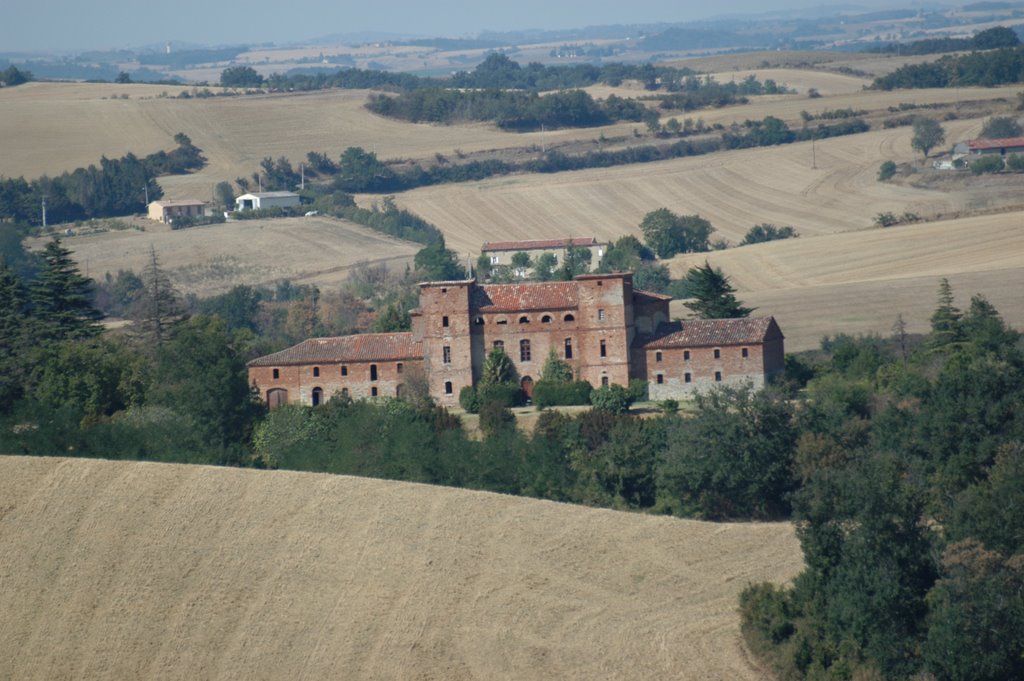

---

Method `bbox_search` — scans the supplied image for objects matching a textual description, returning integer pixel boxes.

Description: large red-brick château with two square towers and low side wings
[249,272,783,408]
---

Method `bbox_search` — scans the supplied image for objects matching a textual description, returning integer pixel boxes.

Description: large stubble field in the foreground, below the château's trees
[0,457,802,681]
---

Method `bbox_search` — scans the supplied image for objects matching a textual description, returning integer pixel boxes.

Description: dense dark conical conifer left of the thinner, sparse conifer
[30,239,102,340]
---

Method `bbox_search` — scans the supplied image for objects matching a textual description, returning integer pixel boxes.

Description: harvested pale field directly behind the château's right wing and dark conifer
[672,212,1024,350]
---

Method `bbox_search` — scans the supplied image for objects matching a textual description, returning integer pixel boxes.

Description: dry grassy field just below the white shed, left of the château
[29,216,422,297]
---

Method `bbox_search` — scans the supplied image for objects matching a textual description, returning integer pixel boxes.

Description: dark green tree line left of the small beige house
[0,132,206,224]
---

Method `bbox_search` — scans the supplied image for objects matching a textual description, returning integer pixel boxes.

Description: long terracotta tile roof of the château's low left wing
[249,332,423,367]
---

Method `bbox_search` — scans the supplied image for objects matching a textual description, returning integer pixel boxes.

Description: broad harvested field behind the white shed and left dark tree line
[0,83,634,199]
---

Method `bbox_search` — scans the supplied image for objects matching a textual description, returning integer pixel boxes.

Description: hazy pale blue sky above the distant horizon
[0,0,847,52]
